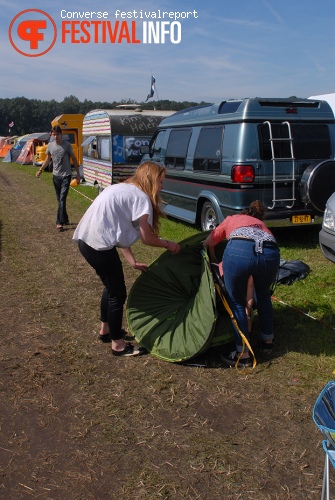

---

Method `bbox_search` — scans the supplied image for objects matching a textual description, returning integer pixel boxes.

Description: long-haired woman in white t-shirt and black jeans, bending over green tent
[73,161,180,356]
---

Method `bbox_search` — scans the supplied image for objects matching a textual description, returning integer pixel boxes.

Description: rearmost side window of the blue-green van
[193,127,223,173]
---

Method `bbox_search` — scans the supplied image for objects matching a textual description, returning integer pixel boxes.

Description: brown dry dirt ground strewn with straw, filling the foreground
[0,164,330,499]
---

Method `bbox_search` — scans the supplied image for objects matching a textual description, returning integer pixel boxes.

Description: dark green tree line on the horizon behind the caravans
[0,95,209,136]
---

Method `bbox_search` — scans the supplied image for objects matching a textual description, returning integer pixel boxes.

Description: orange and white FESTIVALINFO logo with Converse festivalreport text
[8,9,198,57]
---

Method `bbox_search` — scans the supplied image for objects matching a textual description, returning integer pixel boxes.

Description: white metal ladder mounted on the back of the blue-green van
[263,121,296,210]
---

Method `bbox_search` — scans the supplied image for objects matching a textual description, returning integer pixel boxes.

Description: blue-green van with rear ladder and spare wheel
[142,98,335,230]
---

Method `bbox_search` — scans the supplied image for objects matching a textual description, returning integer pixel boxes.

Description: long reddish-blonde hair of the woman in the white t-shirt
[125,161,166,236]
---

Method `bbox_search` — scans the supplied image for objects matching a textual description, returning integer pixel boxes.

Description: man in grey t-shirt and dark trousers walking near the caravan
[36,125,80,231]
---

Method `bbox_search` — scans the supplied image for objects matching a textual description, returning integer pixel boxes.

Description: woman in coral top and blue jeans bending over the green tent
[203,201,280,367]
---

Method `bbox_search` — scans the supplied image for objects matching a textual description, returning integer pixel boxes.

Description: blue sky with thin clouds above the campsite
[0,0,335,102]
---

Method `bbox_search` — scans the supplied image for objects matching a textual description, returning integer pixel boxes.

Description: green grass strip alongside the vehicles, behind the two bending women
[34,165,335,336]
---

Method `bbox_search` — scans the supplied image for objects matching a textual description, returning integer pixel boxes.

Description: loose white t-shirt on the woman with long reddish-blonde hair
[73,183,153,250]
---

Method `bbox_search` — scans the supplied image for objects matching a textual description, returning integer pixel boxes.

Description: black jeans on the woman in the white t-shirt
[78,240,127,340]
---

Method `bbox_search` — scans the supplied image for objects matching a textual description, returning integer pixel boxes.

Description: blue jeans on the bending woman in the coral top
[222,239,280,352]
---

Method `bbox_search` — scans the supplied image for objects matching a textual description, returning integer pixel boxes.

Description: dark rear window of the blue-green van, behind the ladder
[258,123,331,160]
